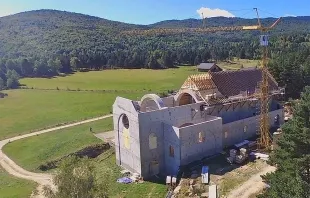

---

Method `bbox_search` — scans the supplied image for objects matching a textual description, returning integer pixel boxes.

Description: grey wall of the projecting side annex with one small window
[179,117,222,165]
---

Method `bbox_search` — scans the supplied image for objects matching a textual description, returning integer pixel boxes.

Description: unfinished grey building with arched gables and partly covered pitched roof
[113,69,284,178]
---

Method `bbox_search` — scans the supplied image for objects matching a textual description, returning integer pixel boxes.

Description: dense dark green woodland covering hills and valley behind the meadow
[0,10,310,97]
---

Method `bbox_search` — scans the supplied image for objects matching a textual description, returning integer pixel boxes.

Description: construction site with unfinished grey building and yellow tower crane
[113,9,285,197]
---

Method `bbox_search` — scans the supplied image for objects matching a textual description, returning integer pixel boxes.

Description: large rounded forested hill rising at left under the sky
[0,10,138,57]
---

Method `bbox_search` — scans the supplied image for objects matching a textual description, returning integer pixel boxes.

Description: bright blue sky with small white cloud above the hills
[0,0,310,24]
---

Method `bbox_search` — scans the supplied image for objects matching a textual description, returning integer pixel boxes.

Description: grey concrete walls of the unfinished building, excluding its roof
[113,97,284,177]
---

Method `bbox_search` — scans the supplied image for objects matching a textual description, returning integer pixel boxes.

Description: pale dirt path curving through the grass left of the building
[0,115,112,198]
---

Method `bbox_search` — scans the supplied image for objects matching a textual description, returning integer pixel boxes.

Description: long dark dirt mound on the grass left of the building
[38,143,111,171]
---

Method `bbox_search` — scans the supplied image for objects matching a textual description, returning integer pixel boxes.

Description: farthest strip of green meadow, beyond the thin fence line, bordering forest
[21,66,197,92]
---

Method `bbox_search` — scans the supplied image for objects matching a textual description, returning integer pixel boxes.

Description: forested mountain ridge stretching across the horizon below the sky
[0,9,310,58]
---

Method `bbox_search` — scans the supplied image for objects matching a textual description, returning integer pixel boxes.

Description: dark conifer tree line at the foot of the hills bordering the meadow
[0,35,310,98]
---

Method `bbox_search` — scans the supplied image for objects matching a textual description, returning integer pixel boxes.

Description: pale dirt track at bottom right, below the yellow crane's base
[227,166,276,198]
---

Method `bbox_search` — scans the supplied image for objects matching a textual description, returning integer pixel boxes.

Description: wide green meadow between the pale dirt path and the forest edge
[0,67,196,140]
